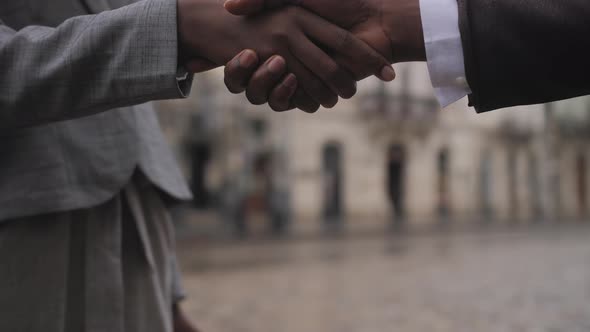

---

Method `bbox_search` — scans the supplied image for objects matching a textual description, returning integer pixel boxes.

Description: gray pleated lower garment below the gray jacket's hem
[0,176,183,332]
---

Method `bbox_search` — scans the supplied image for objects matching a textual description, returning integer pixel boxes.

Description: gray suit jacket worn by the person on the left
[0,0,192,221]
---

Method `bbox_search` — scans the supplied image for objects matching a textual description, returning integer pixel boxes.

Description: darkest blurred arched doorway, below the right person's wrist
[387,144,406,225]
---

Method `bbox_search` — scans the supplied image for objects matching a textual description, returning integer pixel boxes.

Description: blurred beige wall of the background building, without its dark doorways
[155,64,590,225]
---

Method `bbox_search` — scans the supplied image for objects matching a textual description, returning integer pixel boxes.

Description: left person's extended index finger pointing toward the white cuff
[299,12,393,80]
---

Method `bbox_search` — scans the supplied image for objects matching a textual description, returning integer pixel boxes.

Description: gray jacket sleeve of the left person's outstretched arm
[0,0,192,129]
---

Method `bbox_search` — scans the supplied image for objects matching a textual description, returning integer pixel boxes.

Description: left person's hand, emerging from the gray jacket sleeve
[178,0,393,112]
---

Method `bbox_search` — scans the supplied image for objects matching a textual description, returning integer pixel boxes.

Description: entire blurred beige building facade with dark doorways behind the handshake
[160,64,590,230]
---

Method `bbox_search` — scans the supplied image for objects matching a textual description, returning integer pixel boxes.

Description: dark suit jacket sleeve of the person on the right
[458,0,590,112]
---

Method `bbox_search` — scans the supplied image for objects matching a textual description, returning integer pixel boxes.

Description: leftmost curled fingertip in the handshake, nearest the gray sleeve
[223,50,258,93]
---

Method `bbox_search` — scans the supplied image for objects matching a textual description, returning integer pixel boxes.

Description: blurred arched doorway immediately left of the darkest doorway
[322,142,343,227]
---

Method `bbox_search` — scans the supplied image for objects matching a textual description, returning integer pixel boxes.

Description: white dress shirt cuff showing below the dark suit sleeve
[420,0,471,107]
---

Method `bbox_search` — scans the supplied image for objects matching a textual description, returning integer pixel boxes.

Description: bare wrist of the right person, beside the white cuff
[381,0,426,62]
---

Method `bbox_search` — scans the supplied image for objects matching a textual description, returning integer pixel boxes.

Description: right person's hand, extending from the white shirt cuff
[220,0,426,111]
